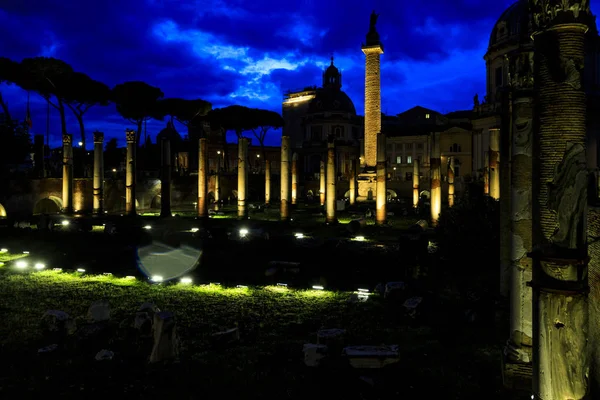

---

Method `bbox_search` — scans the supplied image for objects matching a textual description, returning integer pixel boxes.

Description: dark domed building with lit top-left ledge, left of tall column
[283,57,363,182]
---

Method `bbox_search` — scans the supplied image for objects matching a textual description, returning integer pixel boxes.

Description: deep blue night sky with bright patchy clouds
[0,0,600,145]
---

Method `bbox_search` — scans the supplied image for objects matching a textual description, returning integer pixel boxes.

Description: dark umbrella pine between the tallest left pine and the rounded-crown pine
[64,72,111,152]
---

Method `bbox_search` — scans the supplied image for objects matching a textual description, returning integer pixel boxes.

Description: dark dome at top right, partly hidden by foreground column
[488,0,532,52]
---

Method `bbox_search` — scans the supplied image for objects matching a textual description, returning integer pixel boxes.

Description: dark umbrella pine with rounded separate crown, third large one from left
[111,81,164,146]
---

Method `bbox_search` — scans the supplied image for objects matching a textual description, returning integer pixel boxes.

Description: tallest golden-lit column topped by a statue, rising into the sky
[362,21,383,170]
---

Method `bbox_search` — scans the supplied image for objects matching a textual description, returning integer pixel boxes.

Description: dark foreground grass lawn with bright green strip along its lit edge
[0,254,524,400]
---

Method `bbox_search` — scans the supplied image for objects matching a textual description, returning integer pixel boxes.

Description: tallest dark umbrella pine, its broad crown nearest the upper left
[17,57,73,134]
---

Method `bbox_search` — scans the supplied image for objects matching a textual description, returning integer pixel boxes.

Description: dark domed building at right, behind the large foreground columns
[471,0,600,173]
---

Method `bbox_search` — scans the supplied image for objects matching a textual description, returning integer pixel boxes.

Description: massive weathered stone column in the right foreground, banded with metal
[529,0,595,400]
